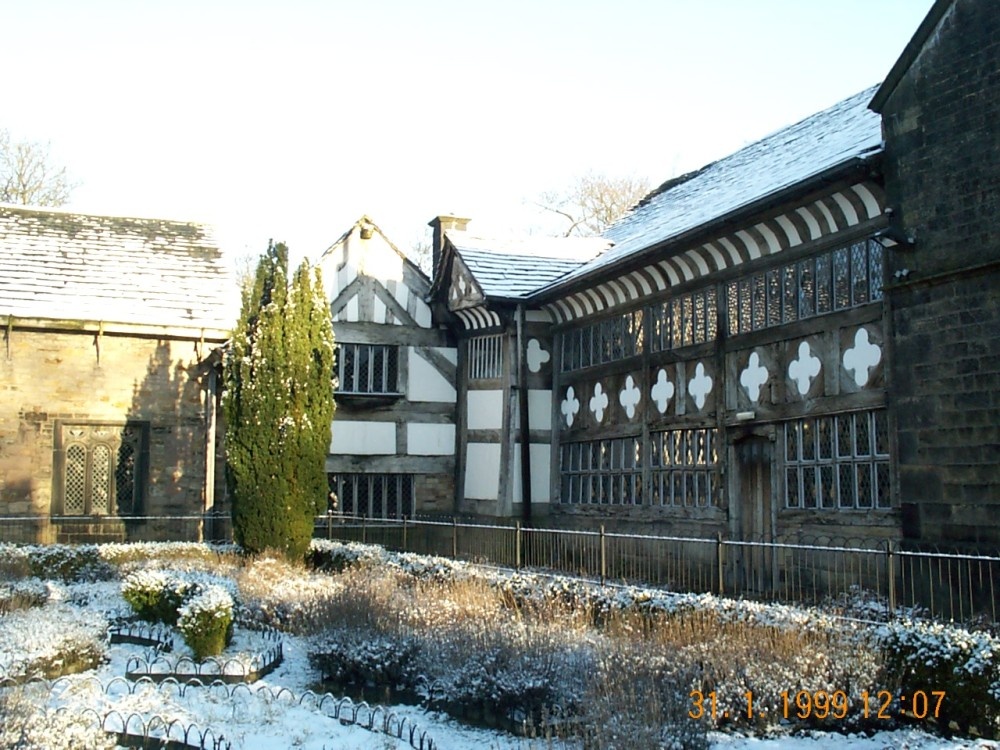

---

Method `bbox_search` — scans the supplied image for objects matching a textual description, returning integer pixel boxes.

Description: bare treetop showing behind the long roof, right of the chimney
[534,172,650,237]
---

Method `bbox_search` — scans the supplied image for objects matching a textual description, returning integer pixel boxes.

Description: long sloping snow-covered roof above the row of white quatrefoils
[554,86,882,287]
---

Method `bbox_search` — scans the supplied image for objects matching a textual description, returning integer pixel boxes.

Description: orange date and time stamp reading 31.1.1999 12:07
[688,690,945,721]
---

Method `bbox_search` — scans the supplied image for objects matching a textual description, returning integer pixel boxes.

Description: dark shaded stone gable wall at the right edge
[882,0,1000,549]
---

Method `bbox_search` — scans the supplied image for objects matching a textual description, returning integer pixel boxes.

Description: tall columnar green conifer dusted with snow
[223,243,334,558]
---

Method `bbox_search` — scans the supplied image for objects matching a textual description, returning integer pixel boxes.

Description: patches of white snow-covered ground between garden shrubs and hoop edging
[0,548,997,750]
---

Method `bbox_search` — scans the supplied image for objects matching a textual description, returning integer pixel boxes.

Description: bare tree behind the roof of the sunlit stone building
[0,130,76,206]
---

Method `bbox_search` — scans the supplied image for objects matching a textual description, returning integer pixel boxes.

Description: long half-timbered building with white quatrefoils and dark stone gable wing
[431,0,1000,556]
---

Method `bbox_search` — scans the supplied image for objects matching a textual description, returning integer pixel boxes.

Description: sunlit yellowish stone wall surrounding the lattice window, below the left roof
[0,326,222,536]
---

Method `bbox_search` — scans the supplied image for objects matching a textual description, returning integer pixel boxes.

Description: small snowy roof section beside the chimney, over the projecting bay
[446,232,611,299]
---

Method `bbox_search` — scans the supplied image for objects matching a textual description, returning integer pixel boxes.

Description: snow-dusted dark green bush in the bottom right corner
[880,620,1000,737]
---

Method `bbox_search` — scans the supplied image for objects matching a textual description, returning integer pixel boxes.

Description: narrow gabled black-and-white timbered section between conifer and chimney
[319,217,457,518]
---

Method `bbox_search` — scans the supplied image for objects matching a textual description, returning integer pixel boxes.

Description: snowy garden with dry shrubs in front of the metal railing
[0,542,1000,750]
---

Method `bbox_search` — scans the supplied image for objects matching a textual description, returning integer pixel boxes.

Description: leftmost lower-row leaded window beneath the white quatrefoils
[559,437,642,505]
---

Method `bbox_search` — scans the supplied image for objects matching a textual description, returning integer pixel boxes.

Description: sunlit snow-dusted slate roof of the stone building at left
[0,204,239,330]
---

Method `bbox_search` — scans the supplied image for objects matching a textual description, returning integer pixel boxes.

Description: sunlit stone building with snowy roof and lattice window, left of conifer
[0,205,237,540]
